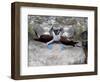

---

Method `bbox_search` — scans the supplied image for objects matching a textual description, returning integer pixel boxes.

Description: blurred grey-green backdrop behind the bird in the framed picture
[28,15,88,47]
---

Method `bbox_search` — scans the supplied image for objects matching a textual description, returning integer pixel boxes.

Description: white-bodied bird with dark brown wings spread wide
[34,25,78,47]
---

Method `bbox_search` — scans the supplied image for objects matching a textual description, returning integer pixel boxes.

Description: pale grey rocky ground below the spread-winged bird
[28,41,85,66]
